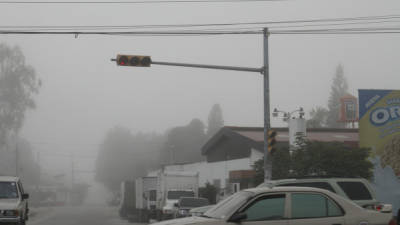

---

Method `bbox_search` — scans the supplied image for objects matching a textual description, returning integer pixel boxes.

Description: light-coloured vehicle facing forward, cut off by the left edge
[0,176,29,225]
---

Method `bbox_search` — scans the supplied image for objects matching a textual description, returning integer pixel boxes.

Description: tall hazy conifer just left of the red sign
[326,64,349,127]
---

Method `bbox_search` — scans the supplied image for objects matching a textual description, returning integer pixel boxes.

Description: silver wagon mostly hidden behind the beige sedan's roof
[258,178,381,210]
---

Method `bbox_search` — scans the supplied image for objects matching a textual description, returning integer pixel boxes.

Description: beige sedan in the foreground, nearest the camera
[150,187,392,225]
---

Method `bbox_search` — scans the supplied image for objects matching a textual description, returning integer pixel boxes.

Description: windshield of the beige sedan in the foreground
[204,191,254,219]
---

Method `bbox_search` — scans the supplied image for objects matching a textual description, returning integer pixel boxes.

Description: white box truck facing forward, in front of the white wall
[157,170,199,220]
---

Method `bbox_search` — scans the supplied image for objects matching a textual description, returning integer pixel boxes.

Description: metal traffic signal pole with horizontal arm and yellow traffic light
[111,28,272,182]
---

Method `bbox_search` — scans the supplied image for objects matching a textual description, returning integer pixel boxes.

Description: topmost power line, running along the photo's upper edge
[0,0,288,4]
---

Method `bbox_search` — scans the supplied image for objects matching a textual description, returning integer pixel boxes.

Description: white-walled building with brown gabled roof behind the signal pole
[147,126,359,193]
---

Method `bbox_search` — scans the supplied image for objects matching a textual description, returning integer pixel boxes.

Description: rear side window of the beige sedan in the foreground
[291,193,343,219]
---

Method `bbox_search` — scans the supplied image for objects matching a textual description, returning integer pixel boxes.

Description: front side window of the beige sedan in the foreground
[243,194,286,221]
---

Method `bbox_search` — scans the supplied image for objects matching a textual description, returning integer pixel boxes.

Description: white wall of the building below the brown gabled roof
[147,149,263,188]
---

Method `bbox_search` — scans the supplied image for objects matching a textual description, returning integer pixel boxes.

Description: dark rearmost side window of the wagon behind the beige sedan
[337,181,372,200]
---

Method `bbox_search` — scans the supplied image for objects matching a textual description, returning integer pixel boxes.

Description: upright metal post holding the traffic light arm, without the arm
[263,28,272,182]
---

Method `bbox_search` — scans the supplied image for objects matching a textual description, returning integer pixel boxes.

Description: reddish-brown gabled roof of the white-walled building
[201,126,359,155]
